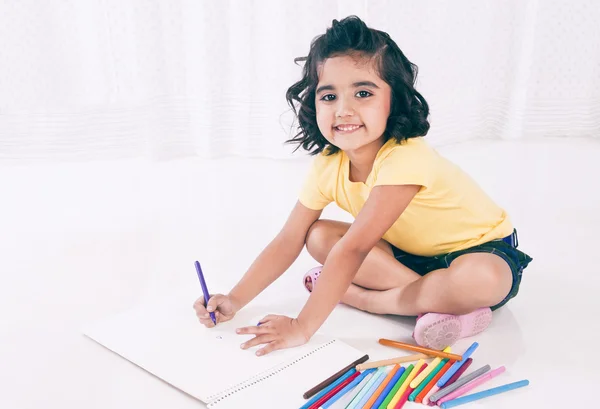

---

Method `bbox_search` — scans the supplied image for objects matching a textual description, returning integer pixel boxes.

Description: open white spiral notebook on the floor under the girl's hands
[83,299,364,409]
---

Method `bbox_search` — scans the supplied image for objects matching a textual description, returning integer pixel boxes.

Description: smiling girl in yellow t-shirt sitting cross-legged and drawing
[194,16,532,355]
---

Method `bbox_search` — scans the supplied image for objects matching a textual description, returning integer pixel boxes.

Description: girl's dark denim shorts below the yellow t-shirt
[392,230,533,311]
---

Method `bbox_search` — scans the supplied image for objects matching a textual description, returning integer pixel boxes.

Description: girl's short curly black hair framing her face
[286,16,429,155]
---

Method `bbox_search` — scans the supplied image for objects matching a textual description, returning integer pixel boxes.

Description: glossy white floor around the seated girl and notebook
[0,140,600,409]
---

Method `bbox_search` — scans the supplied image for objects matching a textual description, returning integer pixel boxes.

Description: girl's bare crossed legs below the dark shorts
[306,220,512,315]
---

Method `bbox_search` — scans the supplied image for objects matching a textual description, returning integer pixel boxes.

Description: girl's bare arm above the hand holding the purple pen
[229,202,322,311]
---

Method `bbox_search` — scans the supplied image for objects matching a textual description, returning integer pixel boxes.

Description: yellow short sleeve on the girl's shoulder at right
[374,139,437,187]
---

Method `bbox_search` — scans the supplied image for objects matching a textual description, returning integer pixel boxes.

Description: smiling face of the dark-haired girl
[315,56,392,152]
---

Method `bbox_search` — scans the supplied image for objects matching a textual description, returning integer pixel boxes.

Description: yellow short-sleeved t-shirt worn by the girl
[299,137,513,256]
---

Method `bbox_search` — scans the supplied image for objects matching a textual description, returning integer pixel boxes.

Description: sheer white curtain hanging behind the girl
[0,0,600,163]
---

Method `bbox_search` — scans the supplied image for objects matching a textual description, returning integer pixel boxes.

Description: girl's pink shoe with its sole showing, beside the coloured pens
[413,307,492,350]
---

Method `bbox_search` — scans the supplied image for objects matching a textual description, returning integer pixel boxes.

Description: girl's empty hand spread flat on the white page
[236,315,310,356]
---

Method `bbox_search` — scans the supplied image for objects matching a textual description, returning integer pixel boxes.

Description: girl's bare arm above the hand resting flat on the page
[297,185,421,338]
